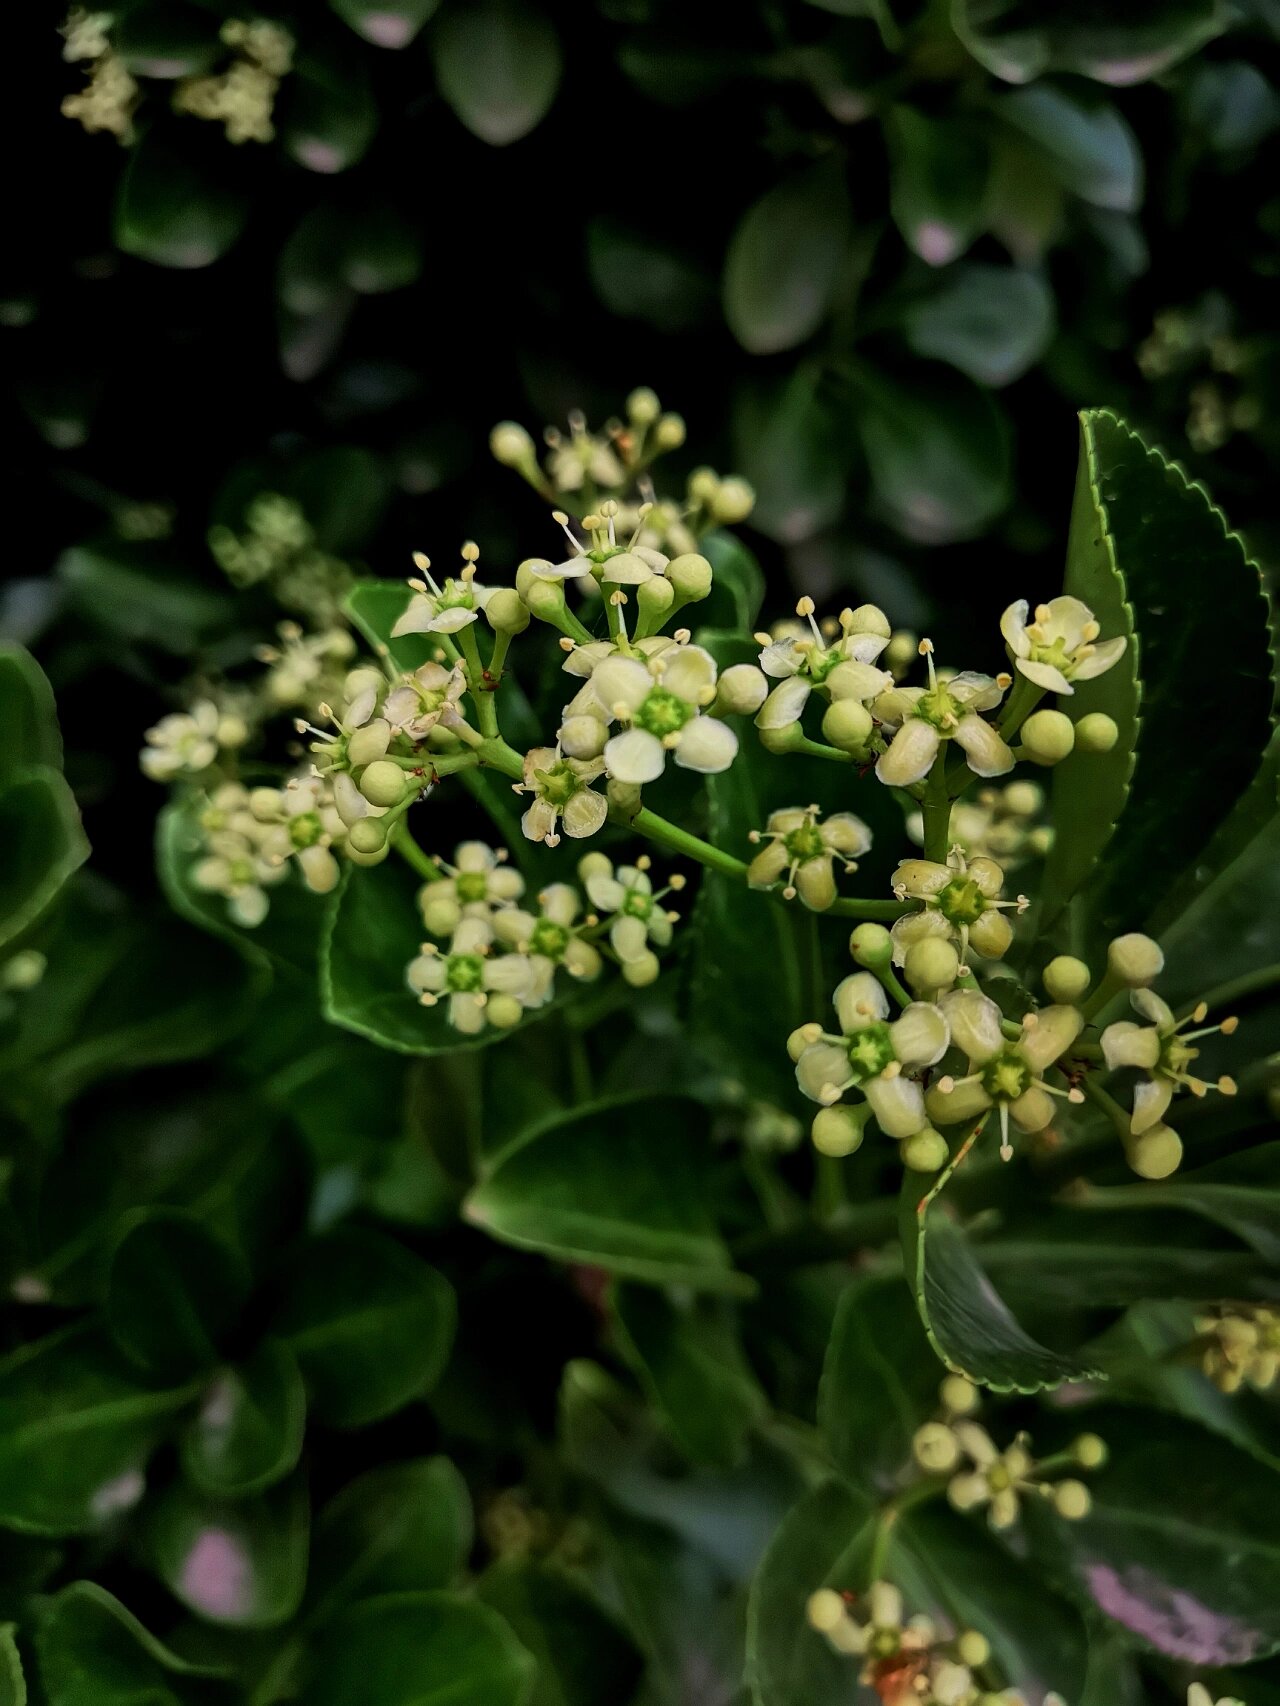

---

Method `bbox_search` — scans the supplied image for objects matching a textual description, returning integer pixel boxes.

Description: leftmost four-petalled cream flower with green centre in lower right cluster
[795,971,951,1138]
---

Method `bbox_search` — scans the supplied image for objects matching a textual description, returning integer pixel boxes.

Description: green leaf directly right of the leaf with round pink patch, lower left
[307,1457,473,1621]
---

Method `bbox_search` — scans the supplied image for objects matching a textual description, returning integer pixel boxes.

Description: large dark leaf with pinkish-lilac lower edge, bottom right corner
[1027,1407,1280,1665]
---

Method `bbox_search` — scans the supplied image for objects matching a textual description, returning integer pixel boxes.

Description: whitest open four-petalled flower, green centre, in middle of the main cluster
[591,645,737,785]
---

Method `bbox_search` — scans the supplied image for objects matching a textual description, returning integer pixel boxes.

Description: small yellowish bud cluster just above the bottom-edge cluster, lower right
[913,1375,1106,1529]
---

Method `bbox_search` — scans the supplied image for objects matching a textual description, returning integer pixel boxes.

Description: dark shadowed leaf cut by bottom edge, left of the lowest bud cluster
[476,1558,642,1706]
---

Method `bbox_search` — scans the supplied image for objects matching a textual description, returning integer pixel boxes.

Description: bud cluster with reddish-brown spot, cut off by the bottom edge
[806,1581,1063,1706]
